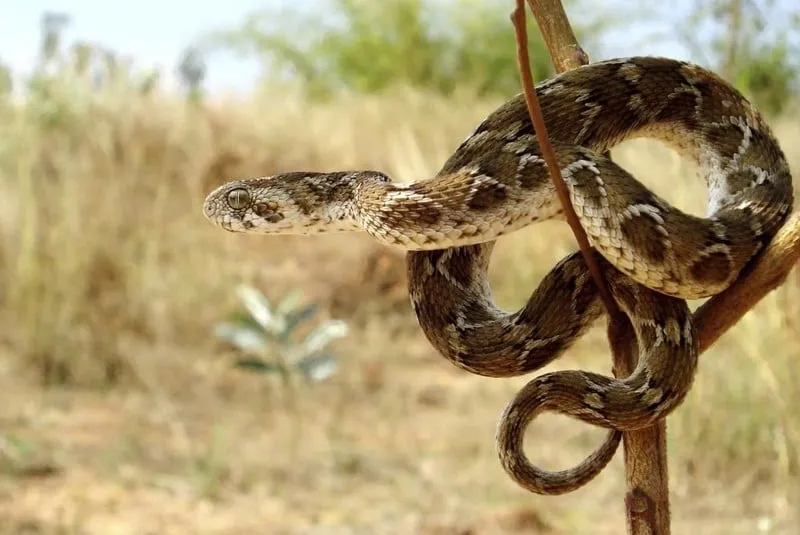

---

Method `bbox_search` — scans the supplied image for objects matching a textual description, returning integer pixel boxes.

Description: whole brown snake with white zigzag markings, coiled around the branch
[204,57,793,494]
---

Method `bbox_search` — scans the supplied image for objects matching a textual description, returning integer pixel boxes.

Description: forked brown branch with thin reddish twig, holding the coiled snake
[512,4,800,535]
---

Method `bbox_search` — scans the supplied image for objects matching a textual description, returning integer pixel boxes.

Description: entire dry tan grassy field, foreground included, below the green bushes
[0,80,800,535]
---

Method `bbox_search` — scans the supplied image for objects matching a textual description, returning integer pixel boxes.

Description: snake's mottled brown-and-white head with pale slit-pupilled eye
[203,172,372,235]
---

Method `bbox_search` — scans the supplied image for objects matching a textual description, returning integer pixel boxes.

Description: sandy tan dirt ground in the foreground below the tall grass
[0,228,798,535]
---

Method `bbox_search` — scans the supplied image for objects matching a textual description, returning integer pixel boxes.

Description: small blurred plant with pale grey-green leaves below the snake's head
[215,285,348,382]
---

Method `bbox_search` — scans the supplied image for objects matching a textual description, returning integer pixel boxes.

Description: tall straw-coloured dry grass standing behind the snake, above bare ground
[0,77,800,532]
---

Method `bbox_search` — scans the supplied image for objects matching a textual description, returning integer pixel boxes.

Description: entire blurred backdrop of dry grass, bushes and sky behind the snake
[0,0,800,535]
